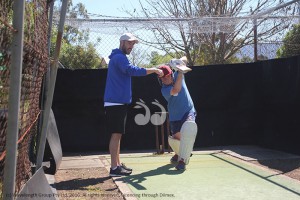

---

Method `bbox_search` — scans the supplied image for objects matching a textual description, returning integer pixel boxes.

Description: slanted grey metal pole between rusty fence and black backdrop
[35,0,68,171]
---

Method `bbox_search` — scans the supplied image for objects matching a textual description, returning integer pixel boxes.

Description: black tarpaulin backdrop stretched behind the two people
[53,56,300,154]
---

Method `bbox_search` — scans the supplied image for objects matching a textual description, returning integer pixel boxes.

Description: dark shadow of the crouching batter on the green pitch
[116,164,184,190]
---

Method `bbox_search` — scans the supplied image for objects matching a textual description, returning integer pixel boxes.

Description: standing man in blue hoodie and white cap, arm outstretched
[104,33,162,176]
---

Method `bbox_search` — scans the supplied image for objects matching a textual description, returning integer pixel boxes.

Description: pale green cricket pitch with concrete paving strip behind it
[51,146,300,200]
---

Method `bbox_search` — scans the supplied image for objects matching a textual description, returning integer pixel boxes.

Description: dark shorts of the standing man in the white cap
[104,105,127,134]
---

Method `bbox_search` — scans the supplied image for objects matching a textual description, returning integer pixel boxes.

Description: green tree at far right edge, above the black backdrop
[276,24,300,58]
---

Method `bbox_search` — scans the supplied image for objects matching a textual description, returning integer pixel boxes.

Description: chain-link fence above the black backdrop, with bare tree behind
[61,11,300,69]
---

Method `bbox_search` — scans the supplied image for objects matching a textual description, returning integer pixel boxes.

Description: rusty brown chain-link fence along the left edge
[0,0,48,196]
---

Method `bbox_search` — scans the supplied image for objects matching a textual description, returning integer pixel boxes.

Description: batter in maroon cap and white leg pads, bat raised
[159,65,197,170]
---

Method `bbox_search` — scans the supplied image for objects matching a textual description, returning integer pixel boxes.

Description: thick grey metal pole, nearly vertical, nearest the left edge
[3,0,25,200]
